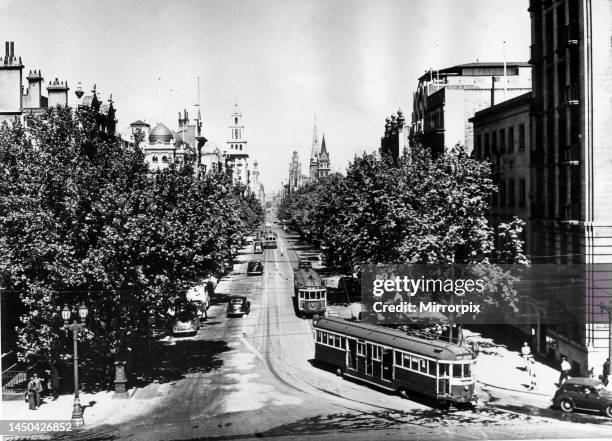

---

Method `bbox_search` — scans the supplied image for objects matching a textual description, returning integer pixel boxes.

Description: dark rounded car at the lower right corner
[553,377,612,418]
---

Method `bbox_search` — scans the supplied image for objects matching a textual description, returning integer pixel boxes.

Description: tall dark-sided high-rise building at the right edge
[529,0,612,374]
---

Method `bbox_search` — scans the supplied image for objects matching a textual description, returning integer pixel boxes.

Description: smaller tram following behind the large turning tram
[293,268,327,315]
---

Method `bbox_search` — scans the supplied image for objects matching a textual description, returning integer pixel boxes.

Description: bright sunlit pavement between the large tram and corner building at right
[463,329,560,398]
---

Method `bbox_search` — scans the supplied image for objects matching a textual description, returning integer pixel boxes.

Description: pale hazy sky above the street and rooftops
[0,0,530,194]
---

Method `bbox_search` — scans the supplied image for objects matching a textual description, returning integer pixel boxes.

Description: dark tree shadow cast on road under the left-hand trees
[133,340,230,387]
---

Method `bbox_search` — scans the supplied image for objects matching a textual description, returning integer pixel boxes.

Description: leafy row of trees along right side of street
[279,146,528,310]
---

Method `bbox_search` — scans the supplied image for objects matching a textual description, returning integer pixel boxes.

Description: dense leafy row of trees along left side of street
[0,108,263,388]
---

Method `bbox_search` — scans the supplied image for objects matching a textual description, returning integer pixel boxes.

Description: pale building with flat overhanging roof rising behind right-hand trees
[410,62,531,154]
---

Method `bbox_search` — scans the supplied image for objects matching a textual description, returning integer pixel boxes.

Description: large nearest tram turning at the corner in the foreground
[314,317,478,407]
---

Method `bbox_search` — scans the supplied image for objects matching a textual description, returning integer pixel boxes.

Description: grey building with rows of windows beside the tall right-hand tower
[470,93,531,254]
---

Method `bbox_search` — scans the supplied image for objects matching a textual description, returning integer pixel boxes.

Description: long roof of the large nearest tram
[315,317,472,360]
